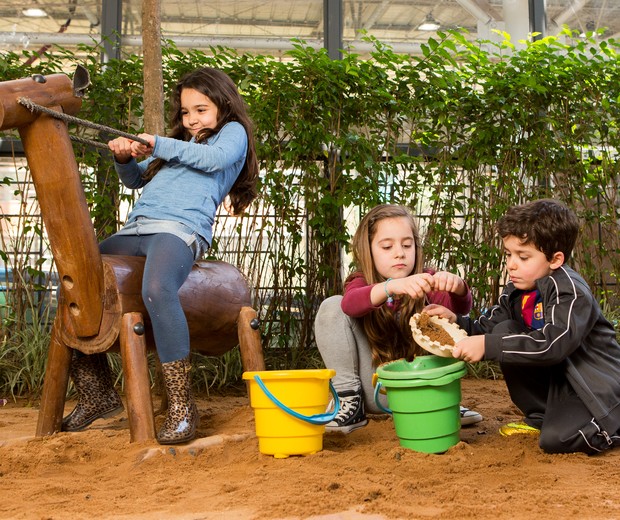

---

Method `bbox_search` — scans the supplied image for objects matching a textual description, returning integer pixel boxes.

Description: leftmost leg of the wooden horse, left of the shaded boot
[36,319,73,437]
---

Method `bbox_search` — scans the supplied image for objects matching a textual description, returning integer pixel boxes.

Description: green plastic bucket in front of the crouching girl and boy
[375,355,467,453]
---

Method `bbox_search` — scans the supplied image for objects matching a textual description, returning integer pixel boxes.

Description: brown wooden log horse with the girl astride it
[0,69,264,442]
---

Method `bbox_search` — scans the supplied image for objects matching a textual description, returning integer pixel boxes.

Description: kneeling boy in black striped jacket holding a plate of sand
[425,199,620,454]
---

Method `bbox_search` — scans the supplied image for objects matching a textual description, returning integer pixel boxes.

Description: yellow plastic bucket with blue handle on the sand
[243,369,339,459]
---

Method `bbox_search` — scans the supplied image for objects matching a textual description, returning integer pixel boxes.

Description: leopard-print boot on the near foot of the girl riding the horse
[157,358,199,444]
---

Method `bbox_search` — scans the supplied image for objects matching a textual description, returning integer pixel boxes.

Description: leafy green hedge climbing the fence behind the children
[0,30,620,398]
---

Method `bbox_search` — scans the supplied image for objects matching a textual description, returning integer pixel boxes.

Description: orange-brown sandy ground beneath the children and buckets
[0,379,620,520]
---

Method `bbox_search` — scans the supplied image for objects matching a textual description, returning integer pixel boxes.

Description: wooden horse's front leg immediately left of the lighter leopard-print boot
[120,312,155,442]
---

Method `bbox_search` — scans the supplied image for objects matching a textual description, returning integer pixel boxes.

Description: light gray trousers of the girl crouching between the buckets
[314,295,387,413]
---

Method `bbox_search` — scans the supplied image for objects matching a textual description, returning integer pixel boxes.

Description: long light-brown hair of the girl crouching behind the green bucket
[351,204,424,366]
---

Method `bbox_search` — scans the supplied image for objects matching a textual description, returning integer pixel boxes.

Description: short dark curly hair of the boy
[497,199,579,261]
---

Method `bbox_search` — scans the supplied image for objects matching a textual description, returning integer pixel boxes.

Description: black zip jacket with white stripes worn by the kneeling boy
[457,265,620,433]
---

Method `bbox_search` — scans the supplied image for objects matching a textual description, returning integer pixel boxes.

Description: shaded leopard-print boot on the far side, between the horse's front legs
[61,350,123,432]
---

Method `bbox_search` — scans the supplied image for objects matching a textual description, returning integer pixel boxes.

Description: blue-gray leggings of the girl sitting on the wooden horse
[99,233,194,363]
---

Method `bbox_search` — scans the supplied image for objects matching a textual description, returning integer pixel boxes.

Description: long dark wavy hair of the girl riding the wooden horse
[143,67,258,215]
